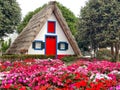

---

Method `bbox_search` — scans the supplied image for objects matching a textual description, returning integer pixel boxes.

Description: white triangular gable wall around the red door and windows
[28,14,75,55]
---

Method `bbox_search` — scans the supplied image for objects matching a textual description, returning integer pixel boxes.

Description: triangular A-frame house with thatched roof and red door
[6,1,81,57]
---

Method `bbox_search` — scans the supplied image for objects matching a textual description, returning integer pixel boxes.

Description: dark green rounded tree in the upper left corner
[0,0,21,39]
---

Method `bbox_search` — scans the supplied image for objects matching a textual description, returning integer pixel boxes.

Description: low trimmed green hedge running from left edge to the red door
[0,55,55,61]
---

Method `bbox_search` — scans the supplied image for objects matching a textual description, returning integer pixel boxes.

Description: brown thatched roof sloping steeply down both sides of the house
[6,1,81,55]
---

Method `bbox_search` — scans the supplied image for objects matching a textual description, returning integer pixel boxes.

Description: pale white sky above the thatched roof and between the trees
[17,0,88,17]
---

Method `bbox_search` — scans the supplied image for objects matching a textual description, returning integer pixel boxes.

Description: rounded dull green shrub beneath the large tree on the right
[96,48,112,60]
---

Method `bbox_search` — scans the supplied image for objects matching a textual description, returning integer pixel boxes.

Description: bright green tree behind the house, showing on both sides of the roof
[18,2,77,35]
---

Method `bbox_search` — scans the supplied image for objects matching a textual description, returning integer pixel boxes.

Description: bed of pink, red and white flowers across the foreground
[0,59,120,90]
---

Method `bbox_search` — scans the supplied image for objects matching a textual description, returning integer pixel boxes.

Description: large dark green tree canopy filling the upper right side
[77,0,120,59]
